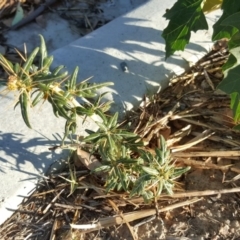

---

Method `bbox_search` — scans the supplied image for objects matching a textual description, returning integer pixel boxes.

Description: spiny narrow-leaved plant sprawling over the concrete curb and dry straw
[0,36,189,201]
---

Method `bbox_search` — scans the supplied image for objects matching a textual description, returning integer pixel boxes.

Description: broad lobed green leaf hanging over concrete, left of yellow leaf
[162,0,208,58]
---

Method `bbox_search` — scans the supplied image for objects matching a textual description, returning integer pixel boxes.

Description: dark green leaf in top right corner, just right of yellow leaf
[212,0,240,41]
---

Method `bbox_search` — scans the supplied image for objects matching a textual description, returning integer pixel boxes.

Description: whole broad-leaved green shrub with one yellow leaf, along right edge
[162,0,240,124]
